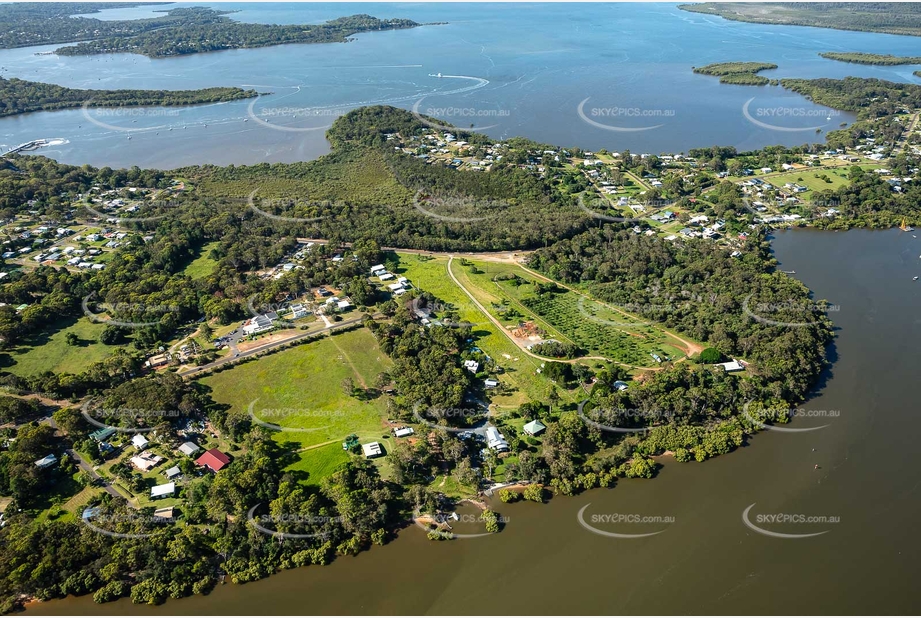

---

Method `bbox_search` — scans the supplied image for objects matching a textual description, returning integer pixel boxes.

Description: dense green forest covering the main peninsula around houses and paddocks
[0,72,921,611]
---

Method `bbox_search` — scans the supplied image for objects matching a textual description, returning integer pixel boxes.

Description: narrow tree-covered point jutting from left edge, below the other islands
[0,77,258,117]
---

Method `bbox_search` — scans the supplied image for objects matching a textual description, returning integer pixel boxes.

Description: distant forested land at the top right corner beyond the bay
[678,2,921,36]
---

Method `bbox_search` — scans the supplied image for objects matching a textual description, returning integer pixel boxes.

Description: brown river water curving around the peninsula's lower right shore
[29,230,921,615]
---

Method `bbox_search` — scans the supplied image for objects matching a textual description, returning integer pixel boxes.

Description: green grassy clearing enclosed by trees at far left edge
[6,317,118,376]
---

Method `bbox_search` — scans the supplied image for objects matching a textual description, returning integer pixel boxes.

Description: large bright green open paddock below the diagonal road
[201,328,391,480]
